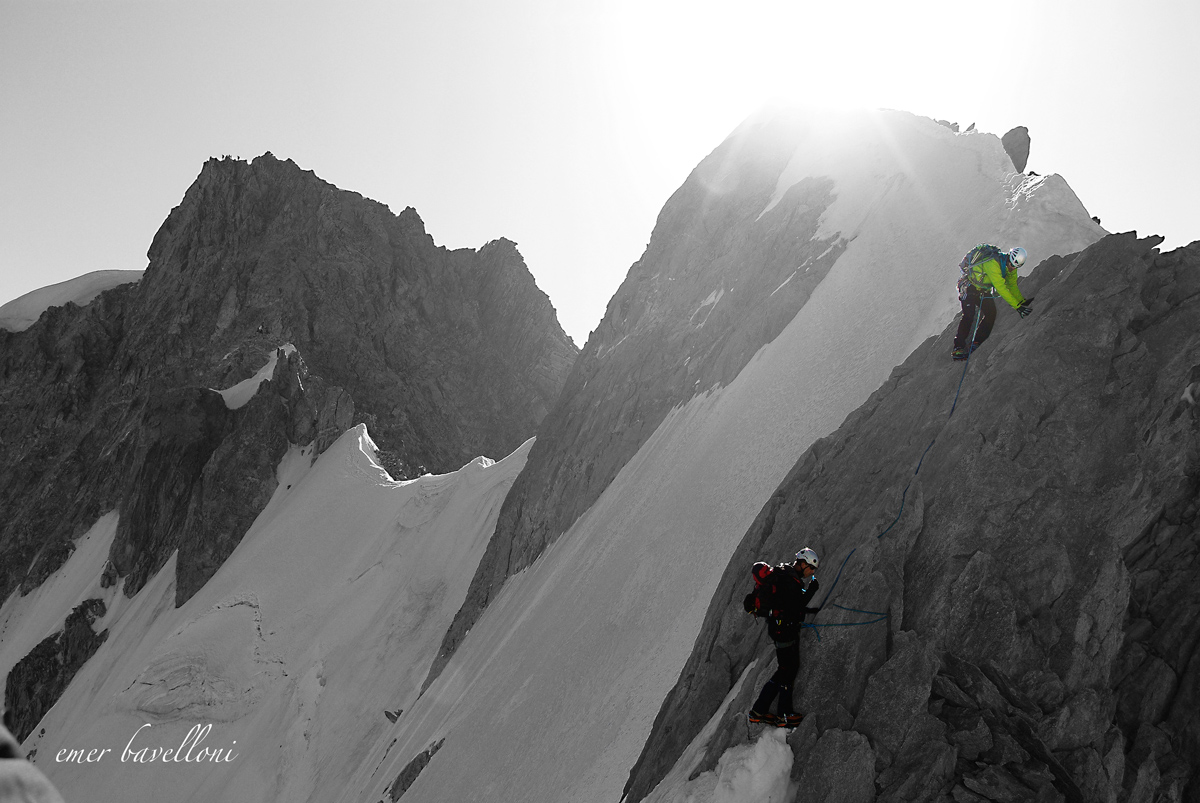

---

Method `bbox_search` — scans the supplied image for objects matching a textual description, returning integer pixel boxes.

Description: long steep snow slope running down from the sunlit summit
[341,112,1102,802]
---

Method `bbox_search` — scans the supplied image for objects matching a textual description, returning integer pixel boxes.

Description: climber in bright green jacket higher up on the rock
[952,242,1033,360]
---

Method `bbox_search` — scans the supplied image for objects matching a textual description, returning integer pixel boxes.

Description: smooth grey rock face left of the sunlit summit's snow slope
[426,105,847,683]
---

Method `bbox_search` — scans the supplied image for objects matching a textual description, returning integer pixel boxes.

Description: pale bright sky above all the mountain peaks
[0,0,1200,346]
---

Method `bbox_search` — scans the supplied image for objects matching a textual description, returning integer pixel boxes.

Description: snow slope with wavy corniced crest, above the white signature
[25,426,532,801]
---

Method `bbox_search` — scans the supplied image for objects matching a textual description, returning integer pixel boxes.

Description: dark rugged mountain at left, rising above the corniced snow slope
[0,154,577,721]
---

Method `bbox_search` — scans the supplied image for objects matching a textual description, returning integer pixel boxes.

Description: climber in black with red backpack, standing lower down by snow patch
[742,547,821,727]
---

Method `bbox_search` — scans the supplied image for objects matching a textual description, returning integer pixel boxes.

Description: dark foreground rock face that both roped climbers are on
[626,234,1200,802]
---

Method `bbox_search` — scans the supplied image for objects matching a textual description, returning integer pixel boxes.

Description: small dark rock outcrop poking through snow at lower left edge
[5,599,108,742]
